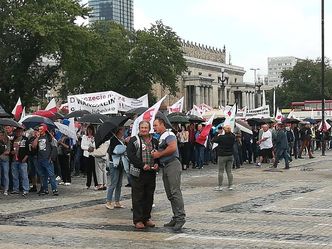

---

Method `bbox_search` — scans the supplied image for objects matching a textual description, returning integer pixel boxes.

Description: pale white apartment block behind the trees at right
[267,56,299,86]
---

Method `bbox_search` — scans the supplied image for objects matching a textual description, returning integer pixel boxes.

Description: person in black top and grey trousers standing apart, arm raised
[212,125,235,191]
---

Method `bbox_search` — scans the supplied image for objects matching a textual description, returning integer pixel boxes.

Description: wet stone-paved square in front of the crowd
[0,151,332,249]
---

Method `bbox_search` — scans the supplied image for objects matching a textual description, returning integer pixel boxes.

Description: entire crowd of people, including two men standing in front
[0,115,331,231]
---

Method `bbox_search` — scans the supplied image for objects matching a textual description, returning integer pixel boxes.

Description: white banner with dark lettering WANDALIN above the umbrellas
[67,91,148,114]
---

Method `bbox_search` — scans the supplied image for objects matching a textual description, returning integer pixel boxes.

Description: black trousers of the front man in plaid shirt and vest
[131,172,156,224]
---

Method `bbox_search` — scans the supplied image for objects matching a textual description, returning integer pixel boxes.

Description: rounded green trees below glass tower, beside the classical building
[62,21,186,100]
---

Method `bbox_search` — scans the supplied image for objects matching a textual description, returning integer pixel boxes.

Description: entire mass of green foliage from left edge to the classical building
[0,0,186,109]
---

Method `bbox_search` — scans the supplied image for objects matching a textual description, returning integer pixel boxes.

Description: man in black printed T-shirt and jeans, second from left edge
[11,128,29,196]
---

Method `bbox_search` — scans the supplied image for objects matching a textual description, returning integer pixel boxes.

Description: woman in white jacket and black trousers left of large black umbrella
[81,125,98,189]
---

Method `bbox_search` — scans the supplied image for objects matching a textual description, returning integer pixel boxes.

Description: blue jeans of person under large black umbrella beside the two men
[106,165,124,202]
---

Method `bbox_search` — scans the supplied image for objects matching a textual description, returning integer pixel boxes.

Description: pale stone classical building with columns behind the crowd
[154,40,255,110]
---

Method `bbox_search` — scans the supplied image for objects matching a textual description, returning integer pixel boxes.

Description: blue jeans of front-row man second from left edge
[12,162,29,192]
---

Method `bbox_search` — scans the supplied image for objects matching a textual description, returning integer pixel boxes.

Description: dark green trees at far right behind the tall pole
[276,59,332,108]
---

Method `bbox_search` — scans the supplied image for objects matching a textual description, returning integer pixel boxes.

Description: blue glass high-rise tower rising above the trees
[88,0,134,30]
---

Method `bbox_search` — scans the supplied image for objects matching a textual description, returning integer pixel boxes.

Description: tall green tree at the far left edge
[0,0,89,109]
